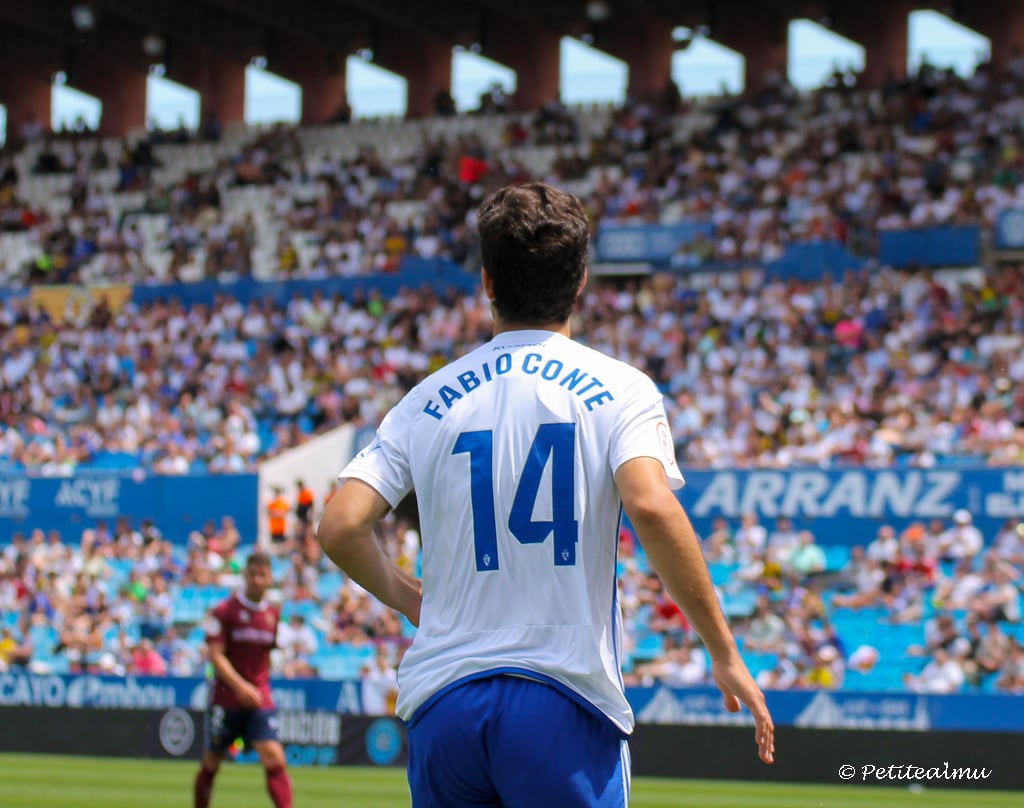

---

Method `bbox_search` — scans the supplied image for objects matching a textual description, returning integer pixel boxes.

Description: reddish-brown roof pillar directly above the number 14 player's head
[483,17,561,111]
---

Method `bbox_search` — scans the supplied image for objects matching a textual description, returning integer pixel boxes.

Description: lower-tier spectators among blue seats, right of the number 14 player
[610,511,1024,693]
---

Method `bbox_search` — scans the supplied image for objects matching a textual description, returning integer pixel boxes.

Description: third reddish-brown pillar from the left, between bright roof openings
[165,48,246,125]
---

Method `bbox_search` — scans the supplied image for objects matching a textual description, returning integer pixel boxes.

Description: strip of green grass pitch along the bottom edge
[0,755,1024,808]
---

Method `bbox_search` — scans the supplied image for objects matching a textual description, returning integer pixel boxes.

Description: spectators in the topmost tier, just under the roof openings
[6,58,1024,282]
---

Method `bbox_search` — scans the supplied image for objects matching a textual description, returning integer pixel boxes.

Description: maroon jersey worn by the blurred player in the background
[206,594,281,710]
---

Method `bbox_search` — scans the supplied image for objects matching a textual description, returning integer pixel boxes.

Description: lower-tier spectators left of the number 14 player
[0,507,418,678]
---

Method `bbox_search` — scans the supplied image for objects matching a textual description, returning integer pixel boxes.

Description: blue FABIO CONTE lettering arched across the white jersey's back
[423,353,615,421]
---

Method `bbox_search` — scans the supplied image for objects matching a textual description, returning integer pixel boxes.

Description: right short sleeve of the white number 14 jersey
[608,376,684,488]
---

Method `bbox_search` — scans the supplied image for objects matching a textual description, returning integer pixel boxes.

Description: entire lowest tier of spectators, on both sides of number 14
[0,497,1024,693]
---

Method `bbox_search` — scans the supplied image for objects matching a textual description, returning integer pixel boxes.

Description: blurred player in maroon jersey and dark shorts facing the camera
[195,553,292,808]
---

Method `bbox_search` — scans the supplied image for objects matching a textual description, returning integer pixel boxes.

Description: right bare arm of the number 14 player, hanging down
[615,458,775,763]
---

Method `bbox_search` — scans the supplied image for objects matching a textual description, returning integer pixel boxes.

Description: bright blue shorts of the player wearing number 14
[409,676,630,808]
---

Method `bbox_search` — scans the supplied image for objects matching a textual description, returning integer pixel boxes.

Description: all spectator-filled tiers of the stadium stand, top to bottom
[0,61,1024,692]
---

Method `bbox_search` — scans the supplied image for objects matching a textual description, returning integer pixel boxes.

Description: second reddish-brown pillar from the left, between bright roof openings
[68,50,145,137]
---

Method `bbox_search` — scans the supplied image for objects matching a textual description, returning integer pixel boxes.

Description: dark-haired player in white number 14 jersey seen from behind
[318,183,774,808]
